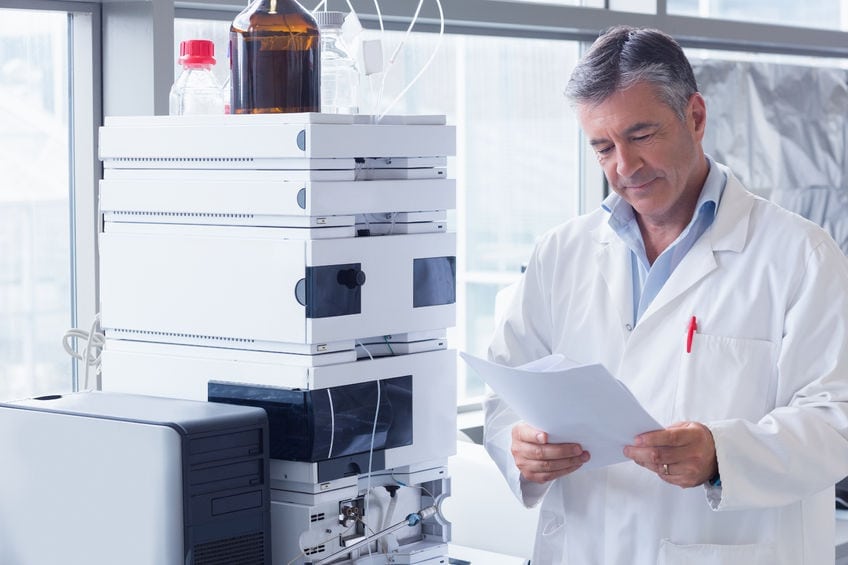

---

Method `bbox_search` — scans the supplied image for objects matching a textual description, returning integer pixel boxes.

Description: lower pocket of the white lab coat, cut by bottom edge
[657,539,777,565]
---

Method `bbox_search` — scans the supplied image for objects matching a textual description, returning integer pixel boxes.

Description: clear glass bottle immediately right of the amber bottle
[315,11,359,114]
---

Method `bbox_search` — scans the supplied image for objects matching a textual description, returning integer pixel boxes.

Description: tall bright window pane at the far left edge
[0,9,71,400]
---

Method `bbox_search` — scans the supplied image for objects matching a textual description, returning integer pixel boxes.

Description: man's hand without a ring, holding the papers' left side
[512,423,589,483]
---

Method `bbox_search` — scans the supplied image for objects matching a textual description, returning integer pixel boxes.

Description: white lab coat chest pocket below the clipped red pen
[673,333,776,422]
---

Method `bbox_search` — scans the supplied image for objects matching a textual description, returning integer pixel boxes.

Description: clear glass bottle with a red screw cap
[168,39,224,116]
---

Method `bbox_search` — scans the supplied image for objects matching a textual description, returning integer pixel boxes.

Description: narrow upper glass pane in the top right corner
[667,0,848,30]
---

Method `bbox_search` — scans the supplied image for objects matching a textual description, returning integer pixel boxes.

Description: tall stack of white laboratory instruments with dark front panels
[99,113,456,565]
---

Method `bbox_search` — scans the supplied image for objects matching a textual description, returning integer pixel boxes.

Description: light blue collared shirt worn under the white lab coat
[601,156,727,326]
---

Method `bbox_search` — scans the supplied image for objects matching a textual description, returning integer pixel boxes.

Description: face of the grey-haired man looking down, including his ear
[577,82,706,225]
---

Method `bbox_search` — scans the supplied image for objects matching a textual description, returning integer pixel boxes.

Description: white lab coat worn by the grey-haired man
[486,161,848,565]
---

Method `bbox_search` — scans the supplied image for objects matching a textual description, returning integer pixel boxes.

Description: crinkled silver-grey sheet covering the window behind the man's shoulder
[692,60,848,254]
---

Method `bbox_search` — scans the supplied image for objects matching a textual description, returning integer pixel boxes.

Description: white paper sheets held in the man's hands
[460,352,662,469]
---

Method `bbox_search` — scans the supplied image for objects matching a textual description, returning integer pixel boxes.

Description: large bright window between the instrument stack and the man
[174,19,578,402]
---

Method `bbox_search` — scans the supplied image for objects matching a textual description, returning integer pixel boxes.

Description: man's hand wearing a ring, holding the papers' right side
[624,422,718,488]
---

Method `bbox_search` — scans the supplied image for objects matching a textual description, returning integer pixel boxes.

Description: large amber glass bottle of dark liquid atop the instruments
[230,0,321,114]
